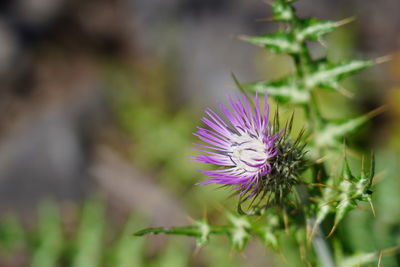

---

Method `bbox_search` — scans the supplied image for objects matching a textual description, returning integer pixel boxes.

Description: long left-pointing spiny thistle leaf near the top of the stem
[238,32,301,54]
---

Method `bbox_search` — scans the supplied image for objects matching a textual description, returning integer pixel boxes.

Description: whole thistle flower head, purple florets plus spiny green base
[194,93,305,210]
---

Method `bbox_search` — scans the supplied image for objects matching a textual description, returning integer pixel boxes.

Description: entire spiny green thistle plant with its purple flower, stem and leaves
[135,0,396,267]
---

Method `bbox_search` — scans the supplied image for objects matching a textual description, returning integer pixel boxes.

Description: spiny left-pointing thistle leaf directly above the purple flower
[242,78,310,104]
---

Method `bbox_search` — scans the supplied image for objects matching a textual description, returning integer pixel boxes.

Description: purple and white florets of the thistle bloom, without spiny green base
[194,95,280,196]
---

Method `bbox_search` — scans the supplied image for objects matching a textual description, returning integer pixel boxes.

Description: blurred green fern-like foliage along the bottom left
[0,198,256,267]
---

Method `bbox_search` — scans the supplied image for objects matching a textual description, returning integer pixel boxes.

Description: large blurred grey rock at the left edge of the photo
[0,86,106,218]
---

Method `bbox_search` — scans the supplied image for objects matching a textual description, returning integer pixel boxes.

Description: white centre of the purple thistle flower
[231,133,269,172]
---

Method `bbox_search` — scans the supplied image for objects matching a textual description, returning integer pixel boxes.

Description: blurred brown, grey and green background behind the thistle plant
[0,0,400,267]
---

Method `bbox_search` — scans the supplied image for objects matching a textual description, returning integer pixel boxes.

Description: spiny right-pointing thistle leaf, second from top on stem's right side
[305,60,374,90]
